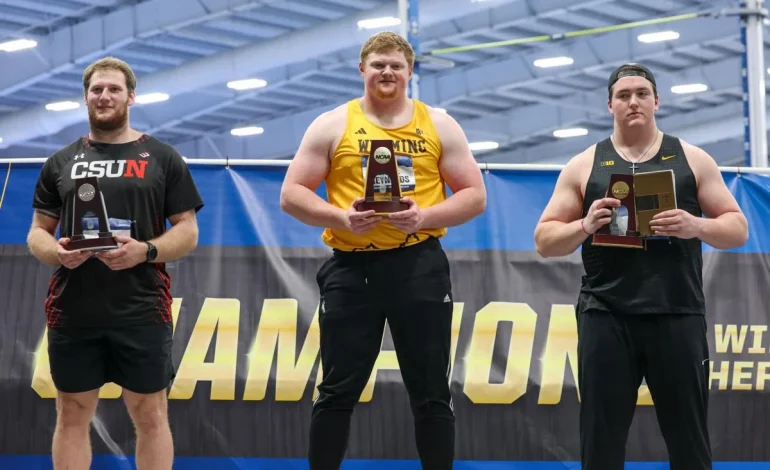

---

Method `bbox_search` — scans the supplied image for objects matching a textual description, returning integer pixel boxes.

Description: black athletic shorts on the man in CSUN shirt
[48,322,176,393]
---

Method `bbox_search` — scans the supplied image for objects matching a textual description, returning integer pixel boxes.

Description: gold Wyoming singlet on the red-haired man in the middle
[322,99,447,251]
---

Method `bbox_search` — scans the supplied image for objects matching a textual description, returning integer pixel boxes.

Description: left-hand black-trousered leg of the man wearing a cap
[578,312,643,470]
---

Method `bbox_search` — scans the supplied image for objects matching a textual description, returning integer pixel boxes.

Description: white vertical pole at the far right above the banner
[741,0,768,167]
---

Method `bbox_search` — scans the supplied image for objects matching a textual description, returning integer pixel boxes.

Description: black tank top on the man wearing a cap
[578,134,705,314]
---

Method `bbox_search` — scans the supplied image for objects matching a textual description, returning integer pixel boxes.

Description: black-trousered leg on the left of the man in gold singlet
[308,253,385,470]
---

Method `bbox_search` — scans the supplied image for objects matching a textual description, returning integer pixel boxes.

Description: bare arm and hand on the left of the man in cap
[535,146,619,258]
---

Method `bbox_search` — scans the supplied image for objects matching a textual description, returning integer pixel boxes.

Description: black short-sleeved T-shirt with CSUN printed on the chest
[33,135,202,328]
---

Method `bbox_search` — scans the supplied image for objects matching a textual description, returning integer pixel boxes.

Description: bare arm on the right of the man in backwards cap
[650,139,749,249]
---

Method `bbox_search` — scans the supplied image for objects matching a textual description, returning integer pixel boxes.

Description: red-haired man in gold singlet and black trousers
[281,32,486,470]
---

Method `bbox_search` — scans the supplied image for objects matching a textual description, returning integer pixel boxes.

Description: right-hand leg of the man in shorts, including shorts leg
[108,322,175,470]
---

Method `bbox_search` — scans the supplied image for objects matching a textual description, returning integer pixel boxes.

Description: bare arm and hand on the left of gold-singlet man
[281,105,382,234]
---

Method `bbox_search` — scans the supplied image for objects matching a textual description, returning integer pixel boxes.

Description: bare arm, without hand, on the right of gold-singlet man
[404,108,487,228]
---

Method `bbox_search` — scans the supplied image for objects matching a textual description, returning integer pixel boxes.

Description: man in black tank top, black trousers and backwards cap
[535,64,747,470]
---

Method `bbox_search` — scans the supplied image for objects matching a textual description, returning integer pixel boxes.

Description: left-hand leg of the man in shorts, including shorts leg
[48,328,105,470]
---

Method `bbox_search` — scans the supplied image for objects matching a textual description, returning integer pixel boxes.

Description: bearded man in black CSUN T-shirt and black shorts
[27,58,203,470]
